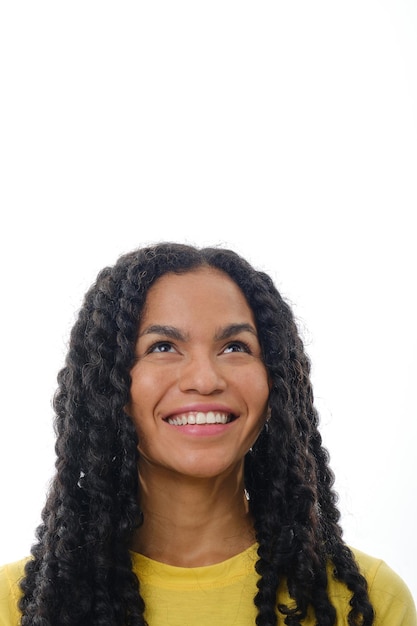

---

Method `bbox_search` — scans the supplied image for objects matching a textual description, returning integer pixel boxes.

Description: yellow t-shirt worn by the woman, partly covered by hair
[0,545,417,626]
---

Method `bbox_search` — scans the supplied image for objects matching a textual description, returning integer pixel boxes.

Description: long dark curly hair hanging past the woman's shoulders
[19,243,373,626]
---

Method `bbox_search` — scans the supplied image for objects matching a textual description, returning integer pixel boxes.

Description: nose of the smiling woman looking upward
[179,354,226,396]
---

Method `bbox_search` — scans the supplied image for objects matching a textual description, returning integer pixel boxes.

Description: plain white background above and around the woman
[0,0,417,597]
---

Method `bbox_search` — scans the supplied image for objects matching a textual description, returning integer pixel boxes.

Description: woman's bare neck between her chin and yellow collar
[131,462,255,567]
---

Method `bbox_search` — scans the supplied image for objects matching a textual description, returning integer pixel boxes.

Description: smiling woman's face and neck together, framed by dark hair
[127,267,269,567]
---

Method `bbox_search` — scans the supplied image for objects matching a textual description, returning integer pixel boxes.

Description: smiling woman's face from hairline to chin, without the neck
[126,268,269,478]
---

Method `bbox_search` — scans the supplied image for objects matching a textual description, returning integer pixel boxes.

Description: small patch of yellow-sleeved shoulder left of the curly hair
[0,559,27,626]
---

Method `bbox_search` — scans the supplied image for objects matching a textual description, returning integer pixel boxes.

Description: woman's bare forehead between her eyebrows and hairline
[141,267,255,326]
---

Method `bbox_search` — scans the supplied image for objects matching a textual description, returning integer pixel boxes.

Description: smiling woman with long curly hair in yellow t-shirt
[0,244,416,626]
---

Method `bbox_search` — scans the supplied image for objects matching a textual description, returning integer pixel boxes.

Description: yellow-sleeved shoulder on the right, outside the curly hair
[351,548,417,626]
